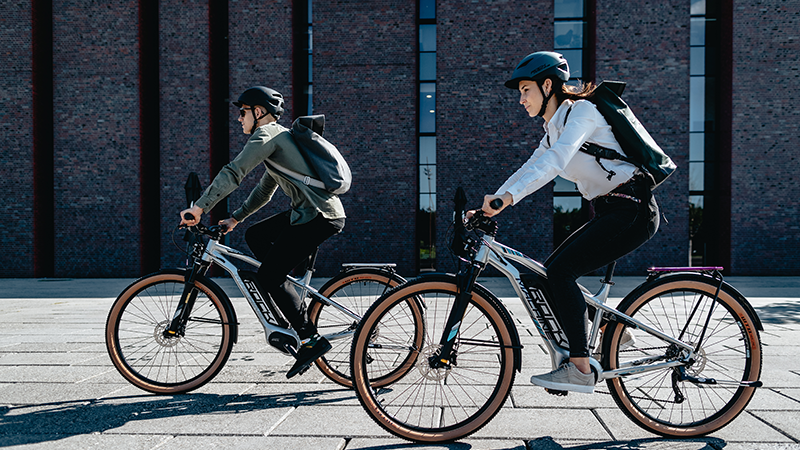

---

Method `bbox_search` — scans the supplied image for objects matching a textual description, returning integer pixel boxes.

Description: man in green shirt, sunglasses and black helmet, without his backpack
[181,86,345,378]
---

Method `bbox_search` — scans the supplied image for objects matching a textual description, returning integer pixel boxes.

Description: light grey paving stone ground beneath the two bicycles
[0,277,800,450]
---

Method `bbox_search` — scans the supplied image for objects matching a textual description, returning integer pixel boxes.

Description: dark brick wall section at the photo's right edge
[731,0,800,275]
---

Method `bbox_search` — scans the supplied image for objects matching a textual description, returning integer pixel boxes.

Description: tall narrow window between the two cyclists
[417,0,436,271]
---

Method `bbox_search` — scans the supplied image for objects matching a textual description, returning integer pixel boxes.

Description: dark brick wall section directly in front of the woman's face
[436,0,553,271]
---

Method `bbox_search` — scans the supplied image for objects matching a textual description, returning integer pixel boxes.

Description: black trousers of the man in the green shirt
[245,211,345,339]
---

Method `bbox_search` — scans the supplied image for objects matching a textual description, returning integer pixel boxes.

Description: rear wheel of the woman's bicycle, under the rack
[604,274,761,438]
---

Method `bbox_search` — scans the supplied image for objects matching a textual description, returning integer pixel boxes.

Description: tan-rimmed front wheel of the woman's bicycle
[351,276,515,442]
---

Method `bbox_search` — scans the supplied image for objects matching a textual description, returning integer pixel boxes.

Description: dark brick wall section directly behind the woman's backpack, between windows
[596,0,689,274]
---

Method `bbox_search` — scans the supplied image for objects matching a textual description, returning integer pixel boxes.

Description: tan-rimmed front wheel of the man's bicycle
[106,271,235,394]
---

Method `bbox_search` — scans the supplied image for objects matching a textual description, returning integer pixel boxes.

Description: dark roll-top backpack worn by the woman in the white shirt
[564,81,677,187]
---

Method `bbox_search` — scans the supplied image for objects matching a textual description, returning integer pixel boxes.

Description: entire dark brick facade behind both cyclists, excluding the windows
[0,0,800,277]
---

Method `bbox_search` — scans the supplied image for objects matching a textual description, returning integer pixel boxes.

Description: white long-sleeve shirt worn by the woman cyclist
[496,100,639,205]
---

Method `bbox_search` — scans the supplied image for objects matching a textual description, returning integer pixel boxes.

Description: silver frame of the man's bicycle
[202,239,361,348]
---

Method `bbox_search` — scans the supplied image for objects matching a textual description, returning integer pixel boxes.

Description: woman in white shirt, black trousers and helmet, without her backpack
[481,52,659,393]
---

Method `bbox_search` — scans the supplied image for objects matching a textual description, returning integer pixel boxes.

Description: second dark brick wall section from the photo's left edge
[53,1,140,277]
